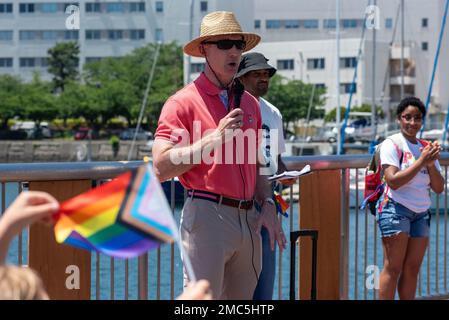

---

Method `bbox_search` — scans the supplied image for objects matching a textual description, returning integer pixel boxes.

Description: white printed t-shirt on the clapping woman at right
[380,135,441,213]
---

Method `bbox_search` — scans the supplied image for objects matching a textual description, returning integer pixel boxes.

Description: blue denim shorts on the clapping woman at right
[376,197,430,238]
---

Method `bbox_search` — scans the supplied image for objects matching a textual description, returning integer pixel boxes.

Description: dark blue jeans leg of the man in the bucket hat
[253,226,276,300]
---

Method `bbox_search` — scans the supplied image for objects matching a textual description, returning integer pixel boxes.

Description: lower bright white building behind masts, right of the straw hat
[187,39,390,111]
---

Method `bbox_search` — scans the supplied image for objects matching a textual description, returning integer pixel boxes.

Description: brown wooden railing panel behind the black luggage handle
[299,170,343,300]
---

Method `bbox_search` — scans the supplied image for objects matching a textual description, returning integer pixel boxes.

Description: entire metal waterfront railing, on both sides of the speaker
[0,153,449,299]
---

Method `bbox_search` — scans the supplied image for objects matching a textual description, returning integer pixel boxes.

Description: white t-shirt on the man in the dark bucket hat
[259,98,285,175]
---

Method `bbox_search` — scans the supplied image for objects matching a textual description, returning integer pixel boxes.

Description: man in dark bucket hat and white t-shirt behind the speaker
[235,52,294,300]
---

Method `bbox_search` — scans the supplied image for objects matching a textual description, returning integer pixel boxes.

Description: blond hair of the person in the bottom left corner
[0,265,48,300]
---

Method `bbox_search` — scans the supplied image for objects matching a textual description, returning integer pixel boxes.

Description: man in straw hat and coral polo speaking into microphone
[153,11,285,299]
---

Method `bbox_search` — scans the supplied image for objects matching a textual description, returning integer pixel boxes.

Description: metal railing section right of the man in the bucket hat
[284,153,449,299]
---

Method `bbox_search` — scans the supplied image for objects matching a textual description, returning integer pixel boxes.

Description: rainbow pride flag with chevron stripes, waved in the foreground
[55,165,178,258]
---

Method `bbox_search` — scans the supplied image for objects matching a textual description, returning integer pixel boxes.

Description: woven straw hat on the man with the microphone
[184,11,260,57]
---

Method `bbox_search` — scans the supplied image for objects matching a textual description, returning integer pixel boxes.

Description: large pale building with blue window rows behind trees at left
[0,0,254,80]
